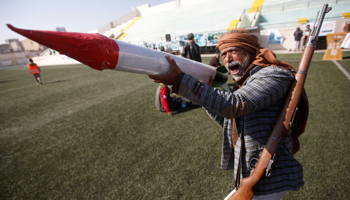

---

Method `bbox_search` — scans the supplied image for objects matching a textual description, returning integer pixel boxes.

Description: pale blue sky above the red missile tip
[0,0,173,44]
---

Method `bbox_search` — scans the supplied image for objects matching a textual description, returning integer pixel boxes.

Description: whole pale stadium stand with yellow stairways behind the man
[98,0,350,52]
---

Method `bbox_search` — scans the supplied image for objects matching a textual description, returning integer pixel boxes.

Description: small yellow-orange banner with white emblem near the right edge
[323,32,346,60]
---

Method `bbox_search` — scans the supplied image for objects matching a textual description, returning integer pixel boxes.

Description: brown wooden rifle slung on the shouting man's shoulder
[225,4,332,200]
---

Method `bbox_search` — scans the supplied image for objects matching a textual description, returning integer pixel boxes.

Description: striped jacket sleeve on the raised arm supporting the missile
[174,67,294,118]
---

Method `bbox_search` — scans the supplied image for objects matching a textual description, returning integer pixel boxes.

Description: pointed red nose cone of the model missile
[7,24,119,70]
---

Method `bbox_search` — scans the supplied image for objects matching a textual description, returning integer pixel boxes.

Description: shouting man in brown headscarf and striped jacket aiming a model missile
[149,28,304,200]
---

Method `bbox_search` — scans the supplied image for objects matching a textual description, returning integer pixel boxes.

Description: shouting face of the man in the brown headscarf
[220,47,252,81]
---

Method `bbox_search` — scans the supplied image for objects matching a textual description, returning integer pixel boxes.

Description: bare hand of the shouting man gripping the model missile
[147,55,182,85]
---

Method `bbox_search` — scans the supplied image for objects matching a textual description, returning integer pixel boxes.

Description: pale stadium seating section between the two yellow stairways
[123,0,253,44]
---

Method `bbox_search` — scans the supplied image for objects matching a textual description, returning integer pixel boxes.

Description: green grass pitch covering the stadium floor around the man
[0,52,350,200]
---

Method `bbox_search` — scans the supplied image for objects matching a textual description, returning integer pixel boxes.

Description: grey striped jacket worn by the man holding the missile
[178,66,304,195]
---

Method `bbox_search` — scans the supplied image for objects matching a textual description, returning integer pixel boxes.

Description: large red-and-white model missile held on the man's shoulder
[7,24,216,83]
